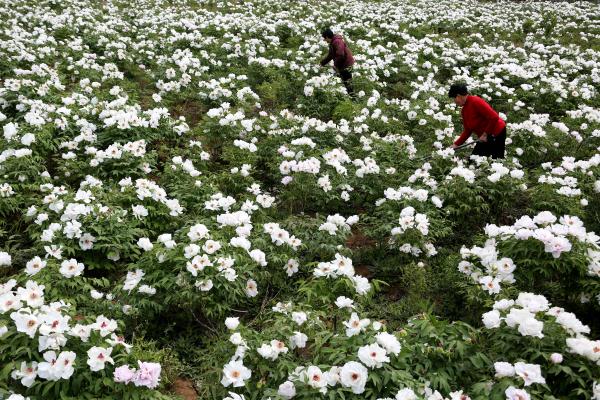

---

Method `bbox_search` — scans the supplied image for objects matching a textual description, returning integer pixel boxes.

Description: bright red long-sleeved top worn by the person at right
[454,96,506,146]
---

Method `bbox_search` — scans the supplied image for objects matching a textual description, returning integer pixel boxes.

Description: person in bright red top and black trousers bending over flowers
[448,83,506,158]
